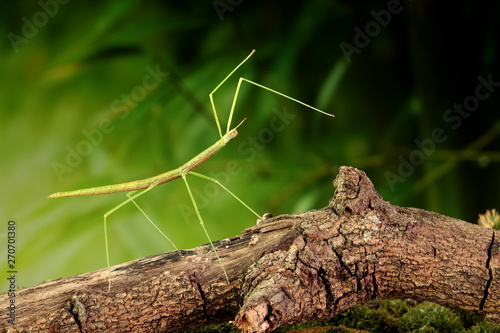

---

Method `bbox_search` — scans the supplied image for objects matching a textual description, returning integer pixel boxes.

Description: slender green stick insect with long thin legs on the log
[49,50,334,291]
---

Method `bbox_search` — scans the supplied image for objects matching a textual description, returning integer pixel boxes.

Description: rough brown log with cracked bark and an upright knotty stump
[0,167,500,332]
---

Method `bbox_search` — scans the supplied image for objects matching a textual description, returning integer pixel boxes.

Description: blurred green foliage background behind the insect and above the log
[0,0,500,290]
